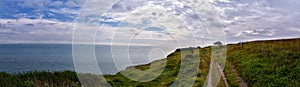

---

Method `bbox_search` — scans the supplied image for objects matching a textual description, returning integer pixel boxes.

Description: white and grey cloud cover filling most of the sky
[0,0,300,45]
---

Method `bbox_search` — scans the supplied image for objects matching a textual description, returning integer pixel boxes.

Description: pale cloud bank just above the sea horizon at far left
[0,19,73,43]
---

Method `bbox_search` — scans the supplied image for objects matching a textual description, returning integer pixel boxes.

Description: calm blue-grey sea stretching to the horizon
[0,44,175,74]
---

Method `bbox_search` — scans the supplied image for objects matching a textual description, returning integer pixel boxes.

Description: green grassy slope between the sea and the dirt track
[105,48,216,87]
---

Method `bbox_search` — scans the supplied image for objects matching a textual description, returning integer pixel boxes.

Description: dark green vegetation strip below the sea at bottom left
[0,71,80,87]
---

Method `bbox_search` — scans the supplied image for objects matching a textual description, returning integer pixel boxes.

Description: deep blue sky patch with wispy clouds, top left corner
[0,0,84,22]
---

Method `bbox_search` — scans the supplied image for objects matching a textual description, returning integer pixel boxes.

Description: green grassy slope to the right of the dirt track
[227,39,300,87]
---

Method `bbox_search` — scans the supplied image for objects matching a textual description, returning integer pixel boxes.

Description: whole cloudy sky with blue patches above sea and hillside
[0,0,300,46]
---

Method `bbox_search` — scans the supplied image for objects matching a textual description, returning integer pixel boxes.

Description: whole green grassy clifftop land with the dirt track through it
[0,39,300,87]
